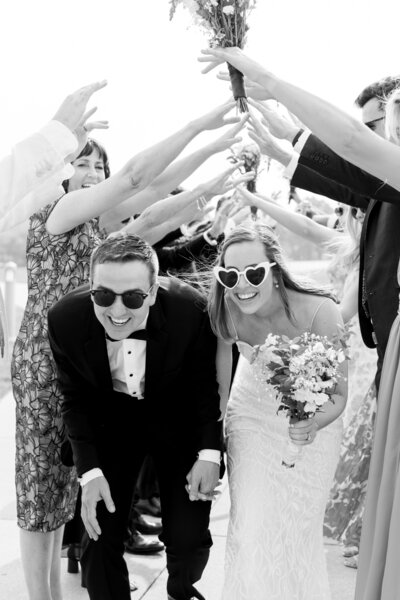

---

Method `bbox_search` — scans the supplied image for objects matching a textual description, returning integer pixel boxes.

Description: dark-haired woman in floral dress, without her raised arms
[11,140,109,600]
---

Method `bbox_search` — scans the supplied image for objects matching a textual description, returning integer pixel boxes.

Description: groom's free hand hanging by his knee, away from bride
[81,477,115,540]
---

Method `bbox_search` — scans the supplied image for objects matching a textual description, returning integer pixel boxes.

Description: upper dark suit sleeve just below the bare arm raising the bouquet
[292,135,400,207]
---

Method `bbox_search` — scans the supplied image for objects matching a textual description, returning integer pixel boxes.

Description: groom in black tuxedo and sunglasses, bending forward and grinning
[48,234,221,600]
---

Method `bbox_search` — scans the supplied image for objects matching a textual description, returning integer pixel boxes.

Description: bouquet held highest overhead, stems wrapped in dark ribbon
[169,0,256,112]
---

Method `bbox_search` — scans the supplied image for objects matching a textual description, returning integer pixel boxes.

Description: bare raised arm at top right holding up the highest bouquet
[200,48,400,190]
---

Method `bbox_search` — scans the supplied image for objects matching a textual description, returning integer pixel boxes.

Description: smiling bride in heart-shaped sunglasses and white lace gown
[209,223,347,600]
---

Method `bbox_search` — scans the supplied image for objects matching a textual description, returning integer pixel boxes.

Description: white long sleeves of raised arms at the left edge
[0,121,78,231]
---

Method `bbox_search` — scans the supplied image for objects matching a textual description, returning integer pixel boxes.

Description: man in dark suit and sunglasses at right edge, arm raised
[250,77,400,387]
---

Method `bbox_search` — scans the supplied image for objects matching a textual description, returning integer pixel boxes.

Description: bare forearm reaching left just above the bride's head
[238,187,342,244]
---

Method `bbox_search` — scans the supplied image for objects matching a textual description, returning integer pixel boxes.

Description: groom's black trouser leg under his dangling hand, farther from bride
[81,398,146,600]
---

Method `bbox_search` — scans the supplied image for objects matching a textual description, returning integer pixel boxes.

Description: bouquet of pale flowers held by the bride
[254,332,350,468]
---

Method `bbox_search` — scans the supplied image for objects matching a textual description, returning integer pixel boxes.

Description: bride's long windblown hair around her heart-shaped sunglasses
[208,222,334,340]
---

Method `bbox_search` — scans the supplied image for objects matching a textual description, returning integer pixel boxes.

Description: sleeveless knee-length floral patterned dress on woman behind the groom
[11,202,101,532]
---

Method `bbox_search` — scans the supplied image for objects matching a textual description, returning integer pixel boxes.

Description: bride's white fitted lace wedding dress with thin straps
[222,342,342,600]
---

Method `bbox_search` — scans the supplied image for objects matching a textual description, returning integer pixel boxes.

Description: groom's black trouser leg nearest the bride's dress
[154,447,212,600]
